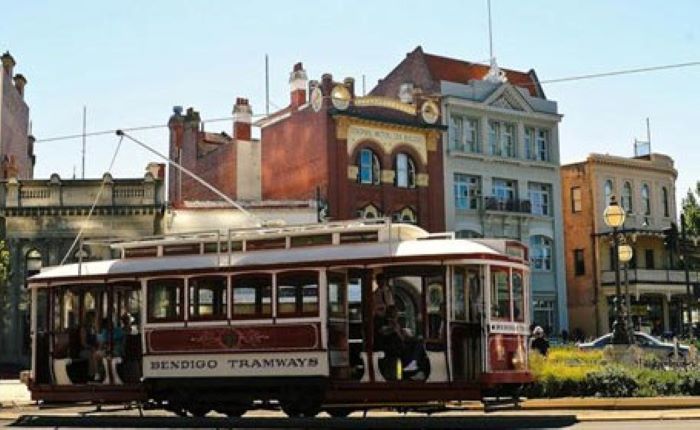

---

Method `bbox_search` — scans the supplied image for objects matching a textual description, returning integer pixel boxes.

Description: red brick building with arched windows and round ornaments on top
[256,63,444,231]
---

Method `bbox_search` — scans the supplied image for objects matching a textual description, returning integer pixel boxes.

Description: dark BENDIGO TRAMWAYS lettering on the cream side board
[151,357,319,370]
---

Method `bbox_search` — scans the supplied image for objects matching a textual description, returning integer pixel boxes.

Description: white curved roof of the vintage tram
[30,224,522,286]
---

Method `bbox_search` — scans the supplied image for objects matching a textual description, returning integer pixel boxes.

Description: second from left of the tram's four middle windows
[188,276,227,320]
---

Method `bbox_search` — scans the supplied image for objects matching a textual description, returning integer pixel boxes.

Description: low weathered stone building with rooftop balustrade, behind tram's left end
[0,164,165,367]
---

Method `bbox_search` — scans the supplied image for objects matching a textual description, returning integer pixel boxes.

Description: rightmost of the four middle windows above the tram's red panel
[277,272,318,317]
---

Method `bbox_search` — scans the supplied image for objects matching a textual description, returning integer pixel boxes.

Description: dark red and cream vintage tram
[29,220,531,416]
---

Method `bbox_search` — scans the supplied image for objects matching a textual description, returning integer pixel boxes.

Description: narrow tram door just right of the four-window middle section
[328,272,351,379]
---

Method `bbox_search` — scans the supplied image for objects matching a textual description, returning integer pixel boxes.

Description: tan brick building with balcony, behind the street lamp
[561,153,698,336]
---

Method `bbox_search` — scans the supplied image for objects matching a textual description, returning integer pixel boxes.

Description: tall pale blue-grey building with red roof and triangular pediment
[372,47,568,333]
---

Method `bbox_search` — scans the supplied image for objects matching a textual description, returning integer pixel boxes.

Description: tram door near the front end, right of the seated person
[450,266,483,382]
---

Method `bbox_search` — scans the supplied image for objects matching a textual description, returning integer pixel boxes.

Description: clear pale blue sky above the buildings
[0,0,700,205]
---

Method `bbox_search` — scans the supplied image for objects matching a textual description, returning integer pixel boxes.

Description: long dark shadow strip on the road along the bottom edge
[10,415,578,430]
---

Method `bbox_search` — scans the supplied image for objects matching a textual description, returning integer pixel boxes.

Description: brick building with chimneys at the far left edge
[0,52,35,179]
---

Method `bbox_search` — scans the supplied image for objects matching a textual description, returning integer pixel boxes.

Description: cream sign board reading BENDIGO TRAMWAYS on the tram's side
[143,352,328,378]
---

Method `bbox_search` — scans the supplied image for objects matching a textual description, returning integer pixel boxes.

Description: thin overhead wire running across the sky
[35,61,700,143]
